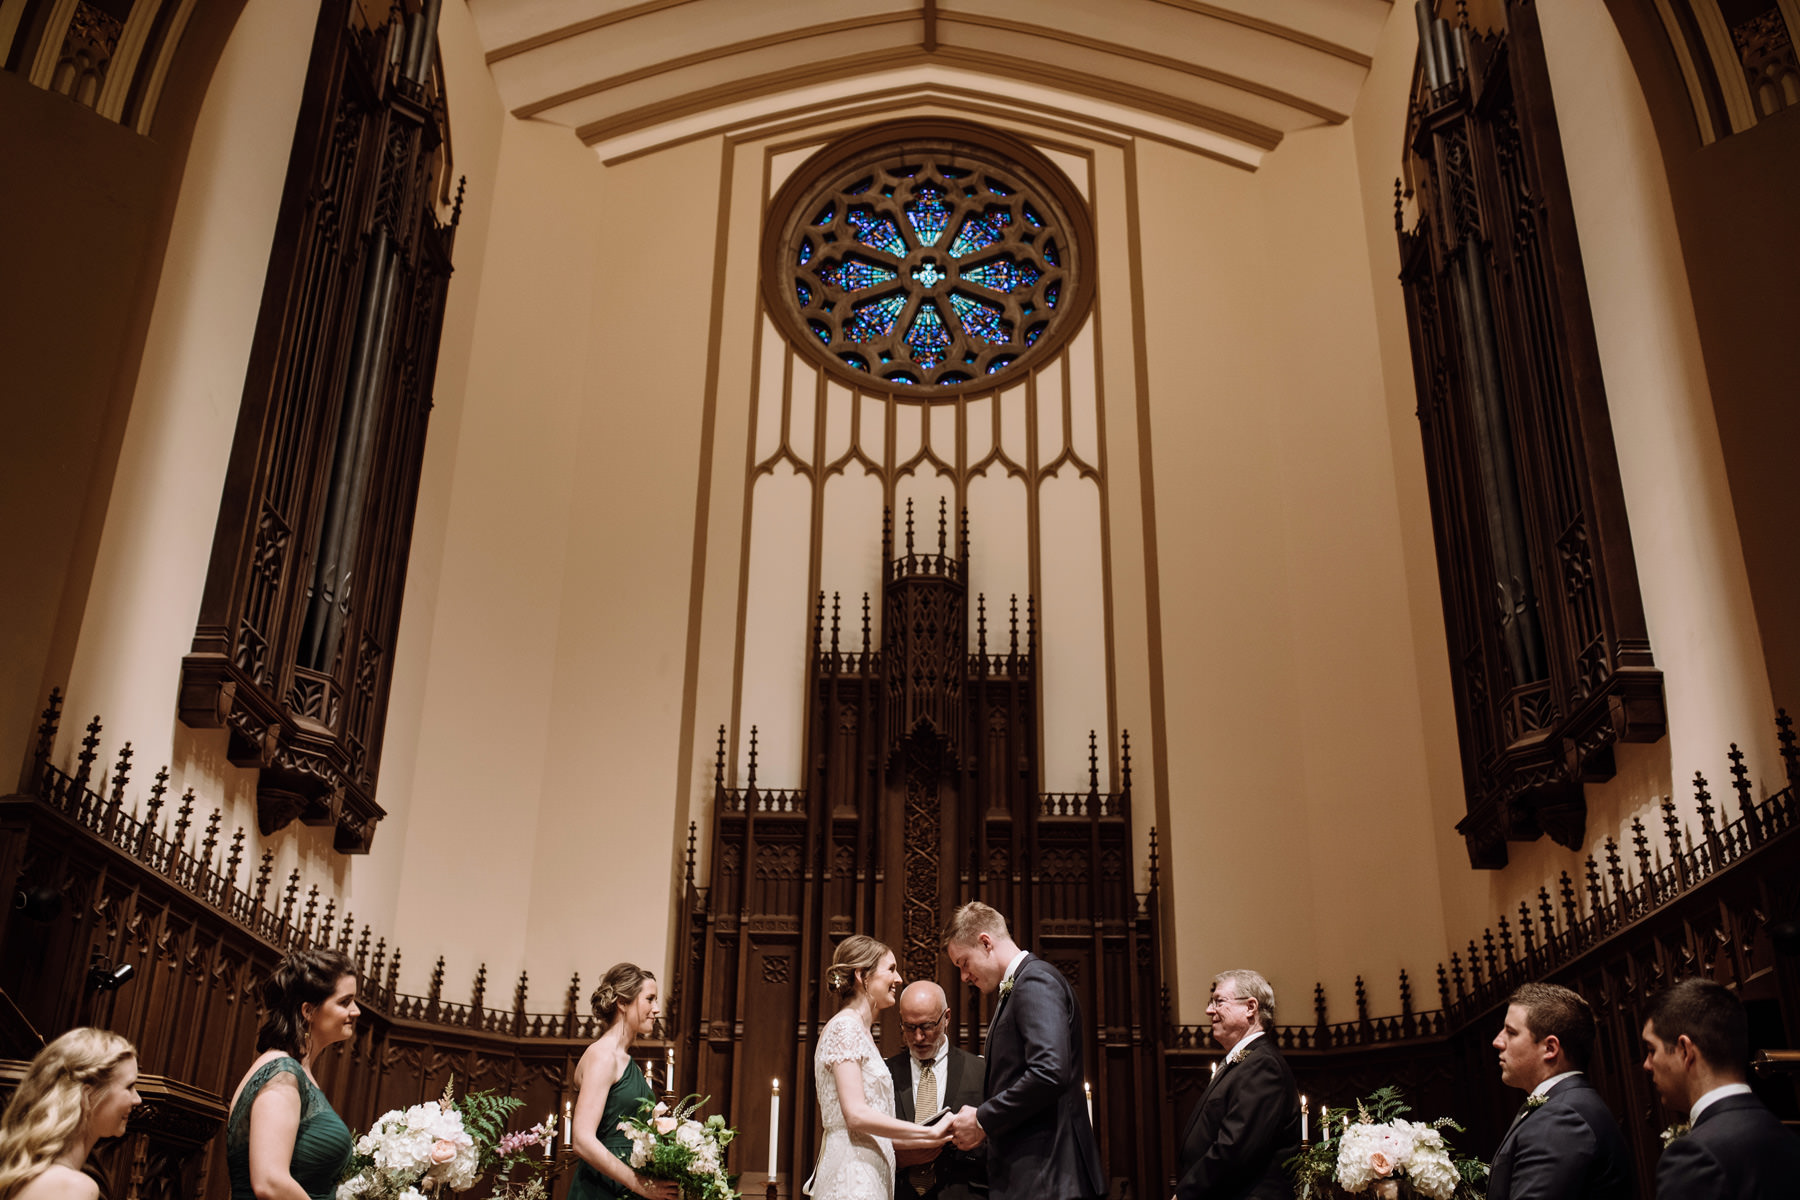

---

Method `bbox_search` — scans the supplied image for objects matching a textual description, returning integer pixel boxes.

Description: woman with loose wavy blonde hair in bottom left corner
[0,1029,144,1200]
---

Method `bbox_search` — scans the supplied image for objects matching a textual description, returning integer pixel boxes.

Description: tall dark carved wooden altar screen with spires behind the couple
[671,513,1166,1195]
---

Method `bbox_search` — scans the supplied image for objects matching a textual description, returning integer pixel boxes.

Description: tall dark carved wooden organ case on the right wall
[1395,0,1665,867]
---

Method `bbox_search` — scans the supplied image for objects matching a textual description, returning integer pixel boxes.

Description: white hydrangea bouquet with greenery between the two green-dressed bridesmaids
[337,1078,554,1200]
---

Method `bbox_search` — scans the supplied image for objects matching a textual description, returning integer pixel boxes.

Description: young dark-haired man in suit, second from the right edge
[1487,984,1633,1200]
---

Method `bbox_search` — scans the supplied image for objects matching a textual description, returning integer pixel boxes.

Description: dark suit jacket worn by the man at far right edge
[1656,1096,1800,1200]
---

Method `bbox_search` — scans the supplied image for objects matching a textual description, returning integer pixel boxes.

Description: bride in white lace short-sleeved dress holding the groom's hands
[806,934,950,1200]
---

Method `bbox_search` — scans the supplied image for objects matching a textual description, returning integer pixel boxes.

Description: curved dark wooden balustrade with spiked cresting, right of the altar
[1163,712,1800,1196]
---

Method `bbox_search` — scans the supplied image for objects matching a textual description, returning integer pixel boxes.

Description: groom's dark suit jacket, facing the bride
[976,955,1107,1200]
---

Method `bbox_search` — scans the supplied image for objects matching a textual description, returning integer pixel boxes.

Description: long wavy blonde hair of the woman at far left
[0,1029,137,1196]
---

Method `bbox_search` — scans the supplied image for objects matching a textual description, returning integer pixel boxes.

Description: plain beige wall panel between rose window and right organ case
[1138,119,1444,1022]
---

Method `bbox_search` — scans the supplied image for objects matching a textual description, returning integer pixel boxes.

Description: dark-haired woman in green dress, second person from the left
[225,946,358,1200]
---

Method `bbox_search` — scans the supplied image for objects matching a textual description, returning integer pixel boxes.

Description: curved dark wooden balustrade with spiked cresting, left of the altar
[0,694,670,1200]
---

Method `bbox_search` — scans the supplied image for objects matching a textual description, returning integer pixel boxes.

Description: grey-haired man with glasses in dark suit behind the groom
[1175,972,1300,1200]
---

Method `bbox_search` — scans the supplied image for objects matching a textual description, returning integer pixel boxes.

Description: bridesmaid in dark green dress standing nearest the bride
[569,963,680,1200]
